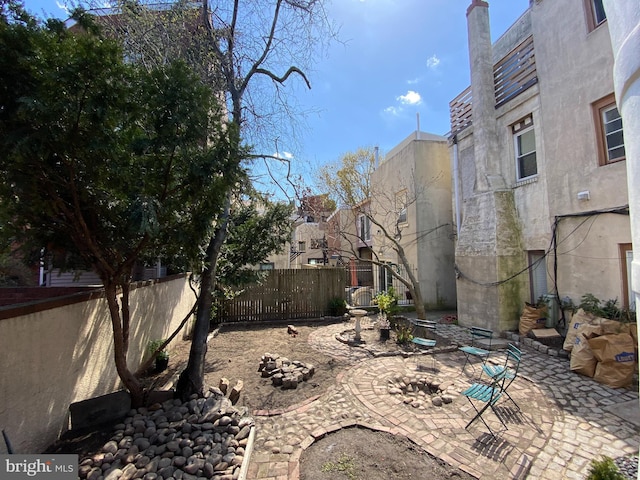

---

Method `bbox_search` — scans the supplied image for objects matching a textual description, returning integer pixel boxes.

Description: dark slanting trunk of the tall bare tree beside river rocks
[176,195,231,401]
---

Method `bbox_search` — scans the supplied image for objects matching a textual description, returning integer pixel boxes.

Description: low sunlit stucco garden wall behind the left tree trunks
[0,276,194,453]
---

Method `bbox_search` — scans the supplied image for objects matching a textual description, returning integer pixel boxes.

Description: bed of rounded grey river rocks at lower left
[78,388,254,480]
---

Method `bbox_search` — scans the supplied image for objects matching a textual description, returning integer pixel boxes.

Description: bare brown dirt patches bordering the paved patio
[51,322,473,480]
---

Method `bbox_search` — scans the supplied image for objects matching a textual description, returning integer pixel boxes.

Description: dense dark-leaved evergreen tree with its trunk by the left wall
[0,4,239,405]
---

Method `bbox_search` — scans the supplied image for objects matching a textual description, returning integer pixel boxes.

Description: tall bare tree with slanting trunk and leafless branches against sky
[91,0,335,398]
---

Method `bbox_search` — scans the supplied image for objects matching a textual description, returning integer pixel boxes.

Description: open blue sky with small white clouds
[21,0,529,182]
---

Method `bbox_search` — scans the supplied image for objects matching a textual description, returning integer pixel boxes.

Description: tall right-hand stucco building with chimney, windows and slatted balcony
[450,0,633,330]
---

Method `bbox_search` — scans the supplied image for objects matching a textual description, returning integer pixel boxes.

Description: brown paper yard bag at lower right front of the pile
[588,333,636,388]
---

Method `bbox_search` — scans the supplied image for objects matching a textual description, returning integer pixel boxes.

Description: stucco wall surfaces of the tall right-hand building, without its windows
[451,0,631,329]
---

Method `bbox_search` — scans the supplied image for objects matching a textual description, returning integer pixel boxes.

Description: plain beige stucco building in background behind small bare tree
[370,131,456,309]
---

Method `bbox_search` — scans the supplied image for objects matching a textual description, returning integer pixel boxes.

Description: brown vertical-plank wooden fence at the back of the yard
[216,268,347,323]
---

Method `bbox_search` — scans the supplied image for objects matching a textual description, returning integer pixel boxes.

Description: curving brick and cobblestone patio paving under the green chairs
[242,316,640,480]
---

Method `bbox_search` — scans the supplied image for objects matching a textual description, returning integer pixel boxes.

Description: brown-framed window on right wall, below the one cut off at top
[593,94,626,165]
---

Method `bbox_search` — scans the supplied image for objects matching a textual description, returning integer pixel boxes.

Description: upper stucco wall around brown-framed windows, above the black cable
[532,0,628,215]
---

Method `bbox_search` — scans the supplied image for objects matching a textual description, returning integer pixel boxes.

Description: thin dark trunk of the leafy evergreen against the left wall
[104,283,144,408]
